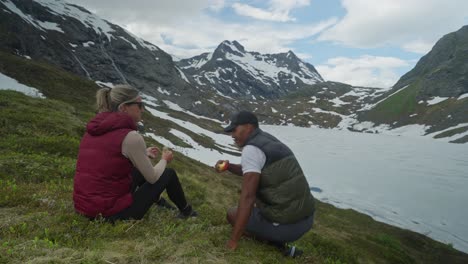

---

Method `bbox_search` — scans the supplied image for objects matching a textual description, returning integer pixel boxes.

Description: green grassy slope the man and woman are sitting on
[0,52,468,263]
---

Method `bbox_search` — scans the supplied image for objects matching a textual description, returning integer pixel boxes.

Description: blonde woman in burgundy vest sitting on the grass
[73,85,197,221]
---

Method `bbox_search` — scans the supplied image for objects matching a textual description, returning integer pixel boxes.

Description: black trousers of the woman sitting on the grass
[108,168,187,222]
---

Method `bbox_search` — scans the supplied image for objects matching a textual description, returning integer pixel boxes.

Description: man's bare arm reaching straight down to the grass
[228,172,260,249]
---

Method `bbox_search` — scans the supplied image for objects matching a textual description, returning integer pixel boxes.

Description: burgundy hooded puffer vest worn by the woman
[73,112,136,217]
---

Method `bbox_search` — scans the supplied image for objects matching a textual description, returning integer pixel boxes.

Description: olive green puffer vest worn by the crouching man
[246,128,315,224]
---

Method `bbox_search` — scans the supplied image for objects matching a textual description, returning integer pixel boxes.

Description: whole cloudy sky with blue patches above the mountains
[67,0,468,87]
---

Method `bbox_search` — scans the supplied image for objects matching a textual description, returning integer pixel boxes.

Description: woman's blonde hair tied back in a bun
[96,84,138,113]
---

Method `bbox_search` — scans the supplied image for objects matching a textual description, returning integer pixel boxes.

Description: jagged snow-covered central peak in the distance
[177,40,324,99]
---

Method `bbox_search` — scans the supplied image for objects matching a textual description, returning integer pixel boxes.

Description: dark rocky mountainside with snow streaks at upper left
[0,0,193,101]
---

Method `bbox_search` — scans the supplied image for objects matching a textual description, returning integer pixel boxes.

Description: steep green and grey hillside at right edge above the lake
[359,26,468,143]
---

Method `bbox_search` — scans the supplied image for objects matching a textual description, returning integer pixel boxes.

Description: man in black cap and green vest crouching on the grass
[215,111,315,257]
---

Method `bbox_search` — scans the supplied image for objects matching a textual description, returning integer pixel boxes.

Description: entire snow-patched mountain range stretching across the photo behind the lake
[0,0,468,143]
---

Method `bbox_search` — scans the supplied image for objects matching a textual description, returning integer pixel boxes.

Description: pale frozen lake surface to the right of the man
[261,126,468,252]
